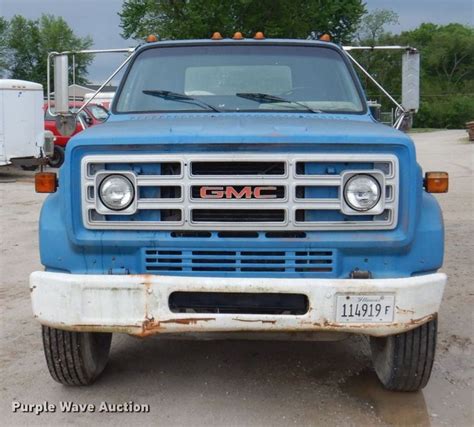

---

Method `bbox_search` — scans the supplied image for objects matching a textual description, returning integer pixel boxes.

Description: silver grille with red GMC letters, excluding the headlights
[81,153,399,232]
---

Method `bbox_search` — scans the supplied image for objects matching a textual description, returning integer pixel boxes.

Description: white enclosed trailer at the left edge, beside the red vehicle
[0,79,45,166]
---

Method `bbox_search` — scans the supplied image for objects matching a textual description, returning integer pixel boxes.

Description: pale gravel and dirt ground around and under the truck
[0,131,474,426]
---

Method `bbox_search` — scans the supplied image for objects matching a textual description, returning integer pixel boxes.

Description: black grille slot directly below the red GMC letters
[191,209,285,222]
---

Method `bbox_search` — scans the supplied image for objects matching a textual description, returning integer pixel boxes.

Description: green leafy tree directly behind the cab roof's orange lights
[119,0,365,42]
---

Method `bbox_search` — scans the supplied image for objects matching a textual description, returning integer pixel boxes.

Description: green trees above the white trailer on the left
[0,15,92,88]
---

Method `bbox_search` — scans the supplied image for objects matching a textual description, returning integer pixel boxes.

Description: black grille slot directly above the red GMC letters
[191,162,285,175]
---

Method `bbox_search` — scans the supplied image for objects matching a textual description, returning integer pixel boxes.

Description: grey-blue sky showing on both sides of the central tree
[0,0,474,83]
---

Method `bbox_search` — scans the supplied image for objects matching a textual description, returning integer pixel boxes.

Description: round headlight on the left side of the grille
[99,175,135,211]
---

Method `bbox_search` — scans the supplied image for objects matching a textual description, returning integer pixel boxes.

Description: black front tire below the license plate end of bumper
[370,319,438,391]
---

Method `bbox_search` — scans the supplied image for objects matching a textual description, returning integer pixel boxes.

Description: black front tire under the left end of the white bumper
[42,326,112,385]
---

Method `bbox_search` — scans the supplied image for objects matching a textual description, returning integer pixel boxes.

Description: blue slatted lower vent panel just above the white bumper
[143,247,335,276]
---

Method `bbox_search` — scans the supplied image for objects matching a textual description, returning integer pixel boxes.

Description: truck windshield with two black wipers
[116,45,364,113]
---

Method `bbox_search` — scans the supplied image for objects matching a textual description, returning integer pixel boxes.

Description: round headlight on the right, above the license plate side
[344,174,381,212]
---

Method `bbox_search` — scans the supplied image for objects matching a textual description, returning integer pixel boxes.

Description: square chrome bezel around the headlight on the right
[340,170,385,215]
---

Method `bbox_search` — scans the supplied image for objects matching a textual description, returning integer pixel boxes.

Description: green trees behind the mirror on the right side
[355,19,474,128]
